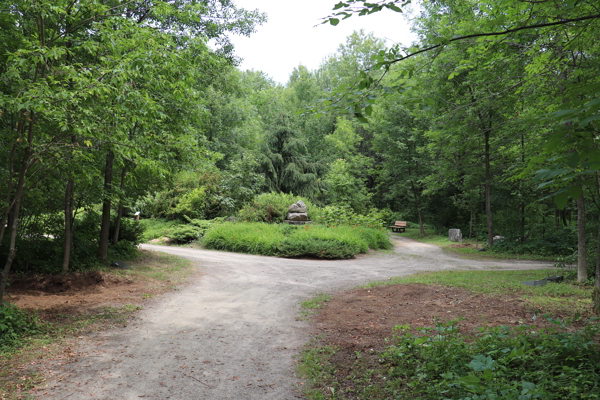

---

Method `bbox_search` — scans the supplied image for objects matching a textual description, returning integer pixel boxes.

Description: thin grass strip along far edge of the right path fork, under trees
[394,228,556,261]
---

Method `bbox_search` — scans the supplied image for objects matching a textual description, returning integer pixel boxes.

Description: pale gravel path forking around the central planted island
[38,237,549,400]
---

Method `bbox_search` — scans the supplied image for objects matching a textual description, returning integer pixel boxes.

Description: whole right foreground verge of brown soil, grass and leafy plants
[298,270,600,400]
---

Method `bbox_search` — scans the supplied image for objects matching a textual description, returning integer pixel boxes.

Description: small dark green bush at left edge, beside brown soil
[0,303,40,352]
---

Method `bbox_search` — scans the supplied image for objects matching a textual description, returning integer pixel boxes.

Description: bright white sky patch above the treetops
[232,0,415,84]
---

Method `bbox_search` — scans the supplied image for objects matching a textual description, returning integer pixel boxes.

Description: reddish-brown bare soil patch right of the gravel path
[313,284,564,381]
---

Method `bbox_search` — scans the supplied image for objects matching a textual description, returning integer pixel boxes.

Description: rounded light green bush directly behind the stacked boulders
[238,192,320,223]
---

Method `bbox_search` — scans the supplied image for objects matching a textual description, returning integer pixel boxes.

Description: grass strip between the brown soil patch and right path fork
[367,269,593,314]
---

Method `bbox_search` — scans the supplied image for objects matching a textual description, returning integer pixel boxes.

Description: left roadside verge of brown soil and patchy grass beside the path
[0,251,198,399]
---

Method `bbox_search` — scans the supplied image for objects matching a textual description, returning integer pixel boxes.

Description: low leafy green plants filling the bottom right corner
[298,320,600,400]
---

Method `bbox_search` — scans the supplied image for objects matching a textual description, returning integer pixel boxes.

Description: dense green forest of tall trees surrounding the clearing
[0,0,600,298]
